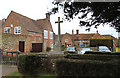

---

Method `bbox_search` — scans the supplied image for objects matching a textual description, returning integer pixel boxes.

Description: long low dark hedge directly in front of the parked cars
[65,54,120,61]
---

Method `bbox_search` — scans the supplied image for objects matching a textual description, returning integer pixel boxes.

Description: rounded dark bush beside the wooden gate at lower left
[18,54,50,76]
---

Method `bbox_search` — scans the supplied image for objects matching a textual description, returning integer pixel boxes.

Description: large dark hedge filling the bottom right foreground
[55,59,120,78]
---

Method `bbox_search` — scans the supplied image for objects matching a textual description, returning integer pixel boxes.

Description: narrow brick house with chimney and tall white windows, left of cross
[37,13,54,49]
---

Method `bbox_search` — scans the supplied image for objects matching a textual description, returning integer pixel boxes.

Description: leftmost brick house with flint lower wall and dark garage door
[2,11,54,52]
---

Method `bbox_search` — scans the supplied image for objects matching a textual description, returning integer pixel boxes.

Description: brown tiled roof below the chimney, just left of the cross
[37,19,53,32]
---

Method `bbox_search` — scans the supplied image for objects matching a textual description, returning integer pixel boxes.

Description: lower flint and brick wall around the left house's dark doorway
[2,34,32,52]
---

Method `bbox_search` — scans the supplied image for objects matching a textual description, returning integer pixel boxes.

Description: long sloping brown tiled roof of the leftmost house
[11,11,42,33]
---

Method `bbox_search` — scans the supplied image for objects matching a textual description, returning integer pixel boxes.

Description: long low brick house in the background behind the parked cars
[55,30,116,47]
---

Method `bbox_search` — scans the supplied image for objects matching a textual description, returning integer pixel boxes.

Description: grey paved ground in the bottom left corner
[2,65,18,76]
